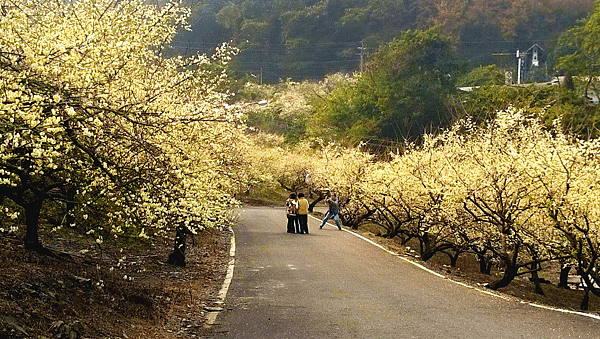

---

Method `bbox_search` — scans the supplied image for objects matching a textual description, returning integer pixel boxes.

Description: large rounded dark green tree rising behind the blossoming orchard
[315,28,462,146]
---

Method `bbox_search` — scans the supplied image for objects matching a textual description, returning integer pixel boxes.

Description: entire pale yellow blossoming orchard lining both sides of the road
[0,0,600,314]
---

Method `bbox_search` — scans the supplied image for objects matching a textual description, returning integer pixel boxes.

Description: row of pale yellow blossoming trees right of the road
[268,108,600,307]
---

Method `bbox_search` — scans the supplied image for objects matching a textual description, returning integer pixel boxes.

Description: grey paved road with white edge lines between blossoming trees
[211,208,600,339]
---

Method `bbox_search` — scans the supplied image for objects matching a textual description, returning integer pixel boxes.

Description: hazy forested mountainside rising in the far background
[173,0,594,82]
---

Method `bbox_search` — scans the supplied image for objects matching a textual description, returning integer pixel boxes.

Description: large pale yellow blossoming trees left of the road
[0,0,254,264]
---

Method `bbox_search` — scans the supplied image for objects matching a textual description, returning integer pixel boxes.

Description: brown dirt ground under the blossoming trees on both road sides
[0,207,600,339]
